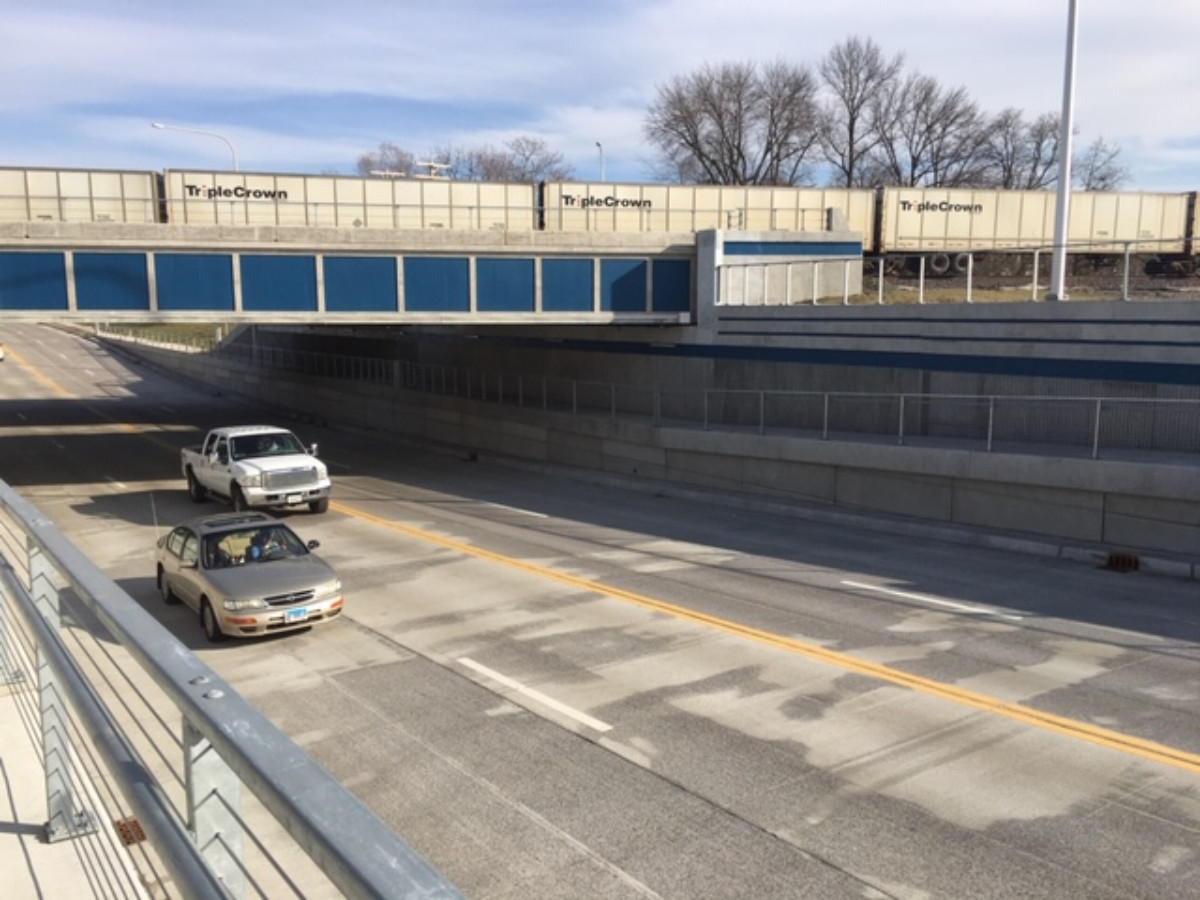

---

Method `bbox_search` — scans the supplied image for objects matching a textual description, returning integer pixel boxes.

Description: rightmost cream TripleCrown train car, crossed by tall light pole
[875,187,1195,275]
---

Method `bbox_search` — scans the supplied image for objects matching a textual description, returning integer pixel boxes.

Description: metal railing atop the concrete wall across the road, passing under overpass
[182,342,1200,460]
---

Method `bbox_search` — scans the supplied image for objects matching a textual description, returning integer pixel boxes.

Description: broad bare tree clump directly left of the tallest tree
[644,62,817,185]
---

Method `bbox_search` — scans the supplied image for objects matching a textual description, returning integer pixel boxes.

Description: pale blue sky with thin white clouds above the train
[0,0,1200,191]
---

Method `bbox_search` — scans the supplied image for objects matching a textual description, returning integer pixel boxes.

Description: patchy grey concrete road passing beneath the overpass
[0,326,1200,900]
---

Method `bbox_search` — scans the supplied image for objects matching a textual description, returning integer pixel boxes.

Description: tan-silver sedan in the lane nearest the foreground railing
[156,512,343,642]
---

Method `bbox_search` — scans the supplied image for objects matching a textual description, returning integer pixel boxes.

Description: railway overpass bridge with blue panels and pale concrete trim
[0,222,863,326]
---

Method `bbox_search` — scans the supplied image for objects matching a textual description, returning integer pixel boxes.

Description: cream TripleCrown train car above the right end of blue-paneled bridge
[541,181,876,239]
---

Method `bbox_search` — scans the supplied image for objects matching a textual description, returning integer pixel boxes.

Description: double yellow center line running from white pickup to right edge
[330,502,1200,774]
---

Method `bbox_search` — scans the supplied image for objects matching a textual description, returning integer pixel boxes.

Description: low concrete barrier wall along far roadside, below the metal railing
[114,342,1200,570]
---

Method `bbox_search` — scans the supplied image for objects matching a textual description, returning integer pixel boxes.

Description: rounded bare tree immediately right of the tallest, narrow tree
[871,74,986,187]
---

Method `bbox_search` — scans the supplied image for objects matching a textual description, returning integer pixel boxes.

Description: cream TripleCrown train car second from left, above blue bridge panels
[163,169,538,230]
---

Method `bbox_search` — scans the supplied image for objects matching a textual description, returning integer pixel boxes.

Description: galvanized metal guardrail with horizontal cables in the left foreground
[0,481,461,900]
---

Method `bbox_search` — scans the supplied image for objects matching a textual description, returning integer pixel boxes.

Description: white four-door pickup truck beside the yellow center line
[181,425,330,512]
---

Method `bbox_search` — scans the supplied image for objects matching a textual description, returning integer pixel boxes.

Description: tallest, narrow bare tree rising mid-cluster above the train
[818,37,904,187]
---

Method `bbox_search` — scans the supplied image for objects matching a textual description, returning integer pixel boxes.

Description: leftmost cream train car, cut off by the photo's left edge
[0,168,161,224]
